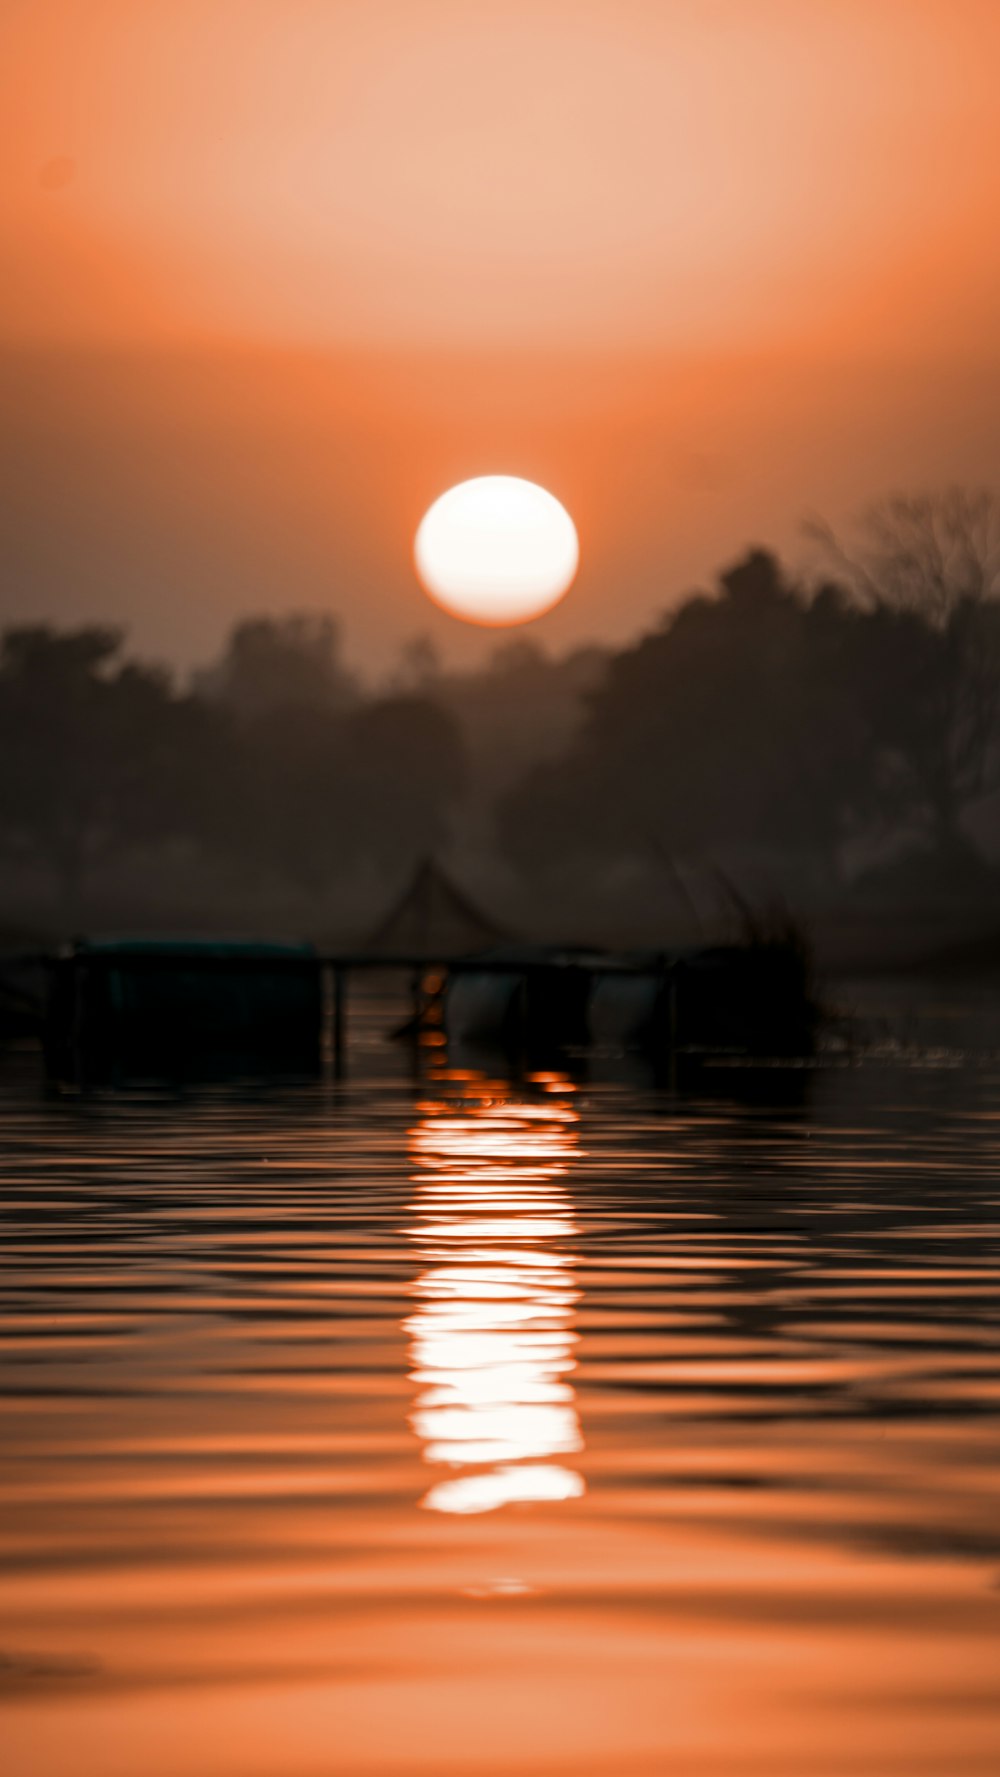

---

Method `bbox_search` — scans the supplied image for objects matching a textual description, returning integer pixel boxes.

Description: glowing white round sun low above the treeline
[414,474,579,626]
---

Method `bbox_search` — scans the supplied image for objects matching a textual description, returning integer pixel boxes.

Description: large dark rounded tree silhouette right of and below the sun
[499,549,870,869]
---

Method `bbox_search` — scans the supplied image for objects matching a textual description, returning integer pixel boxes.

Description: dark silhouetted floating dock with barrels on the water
[44,942,815,1086]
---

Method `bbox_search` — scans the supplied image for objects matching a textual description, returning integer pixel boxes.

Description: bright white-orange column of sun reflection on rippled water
[405,1077,584,1512]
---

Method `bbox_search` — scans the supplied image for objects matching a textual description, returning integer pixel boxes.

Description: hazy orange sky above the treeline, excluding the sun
[0,0,1000,659]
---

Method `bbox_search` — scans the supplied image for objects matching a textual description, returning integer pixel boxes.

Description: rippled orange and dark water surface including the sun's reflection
[0,1030,1000,1777]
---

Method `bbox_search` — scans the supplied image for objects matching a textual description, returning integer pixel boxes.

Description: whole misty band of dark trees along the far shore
[0,492,1000,959]
